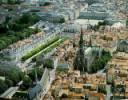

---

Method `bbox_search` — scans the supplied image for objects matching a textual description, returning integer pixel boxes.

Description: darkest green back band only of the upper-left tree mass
[0,13,40,35]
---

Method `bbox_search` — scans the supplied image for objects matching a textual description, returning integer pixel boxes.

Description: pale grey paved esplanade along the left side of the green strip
[0,30,61,69]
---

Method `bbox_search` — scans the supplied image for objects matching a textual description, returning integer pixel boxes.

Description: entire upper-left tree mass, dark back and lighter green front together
[0,14,39,50]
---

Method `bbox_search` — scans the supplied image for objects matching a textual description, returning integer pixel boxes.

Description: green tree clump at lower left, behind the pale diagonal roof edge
[0,68,44,94]
